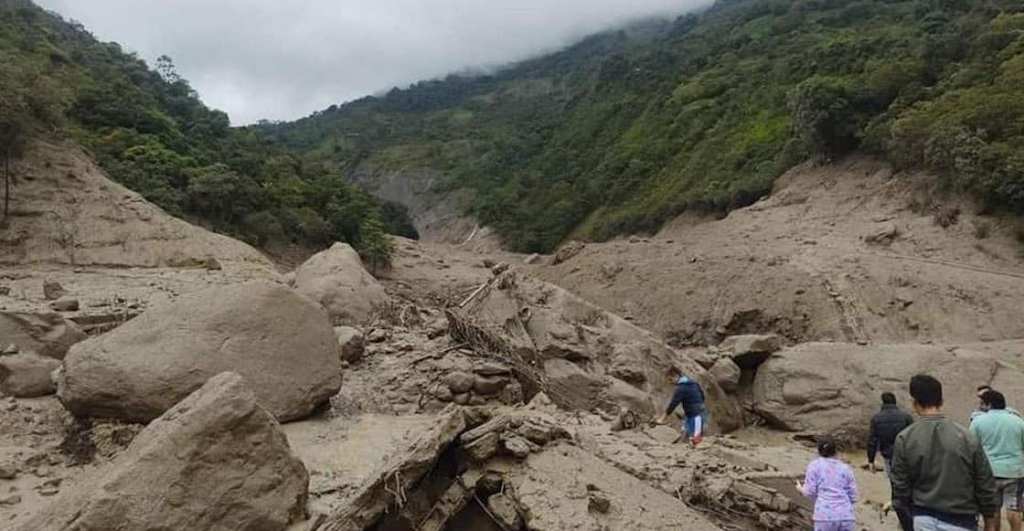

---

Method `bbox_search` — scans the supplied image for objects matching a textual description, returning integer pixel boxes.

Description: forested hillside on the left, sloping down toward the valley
[0,0,413,266]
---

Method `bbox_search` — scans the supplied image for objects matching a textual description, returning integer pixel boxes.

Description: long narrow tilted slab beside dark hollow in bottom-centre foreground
[319,408,466,531]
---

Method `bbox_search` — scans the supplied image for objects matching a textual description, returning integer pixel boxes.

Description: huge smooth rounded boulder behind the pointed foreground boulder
[57,280,341,423]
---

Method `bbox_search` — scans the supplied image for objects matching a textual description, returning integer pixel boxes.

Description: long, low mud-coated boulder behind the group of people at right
[754,343,1024,442]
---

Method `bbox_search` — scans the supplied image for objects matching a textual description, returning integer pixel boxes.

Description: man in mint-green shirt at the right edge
[971,389,1024,531]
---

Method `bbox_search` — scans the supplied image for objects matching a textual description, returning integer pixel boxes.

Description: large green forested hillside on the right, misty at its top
[262,0,1024,251]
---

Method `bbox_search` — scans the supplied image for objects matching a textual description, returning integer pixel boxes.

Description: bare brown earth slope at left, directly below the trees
[0,142,271,269]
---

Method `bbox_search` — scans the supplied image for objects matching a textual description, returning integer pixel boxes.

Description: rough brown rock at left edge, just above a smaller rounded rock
[0,311,86,359]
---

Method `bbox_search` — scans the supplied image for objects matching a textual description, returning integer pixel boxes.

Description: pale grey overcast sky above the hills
[36,0,712,125]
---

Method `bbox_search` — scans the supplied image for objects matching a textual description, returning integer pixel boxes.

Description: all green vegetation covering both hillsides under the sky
[0,0,1024,257]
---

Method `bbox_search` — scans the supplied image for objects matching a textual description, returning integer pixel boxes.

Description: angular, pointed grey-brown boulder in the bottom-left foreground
[19,373,309,531]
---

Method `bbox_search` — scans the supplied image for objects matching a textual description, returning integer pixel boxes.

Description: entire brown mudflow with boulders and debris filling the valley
[0,144,1024,531]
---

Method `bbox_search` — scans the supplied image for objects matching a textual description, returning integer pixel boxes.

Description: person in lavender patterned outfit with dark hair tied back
[797,437,857,531]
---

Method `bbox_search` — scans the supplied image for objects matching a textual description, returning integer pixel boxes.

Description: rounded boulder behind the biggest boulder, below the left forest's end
[295,244,388,324]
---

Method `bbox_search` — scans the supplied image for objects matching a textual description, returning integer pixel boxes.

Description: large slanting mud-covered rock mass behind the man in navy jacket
[460,271,740,430]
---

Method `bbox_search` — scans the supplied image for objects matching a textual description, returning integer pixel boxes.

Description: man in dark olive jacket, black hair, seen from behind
[890,374,999,531]
